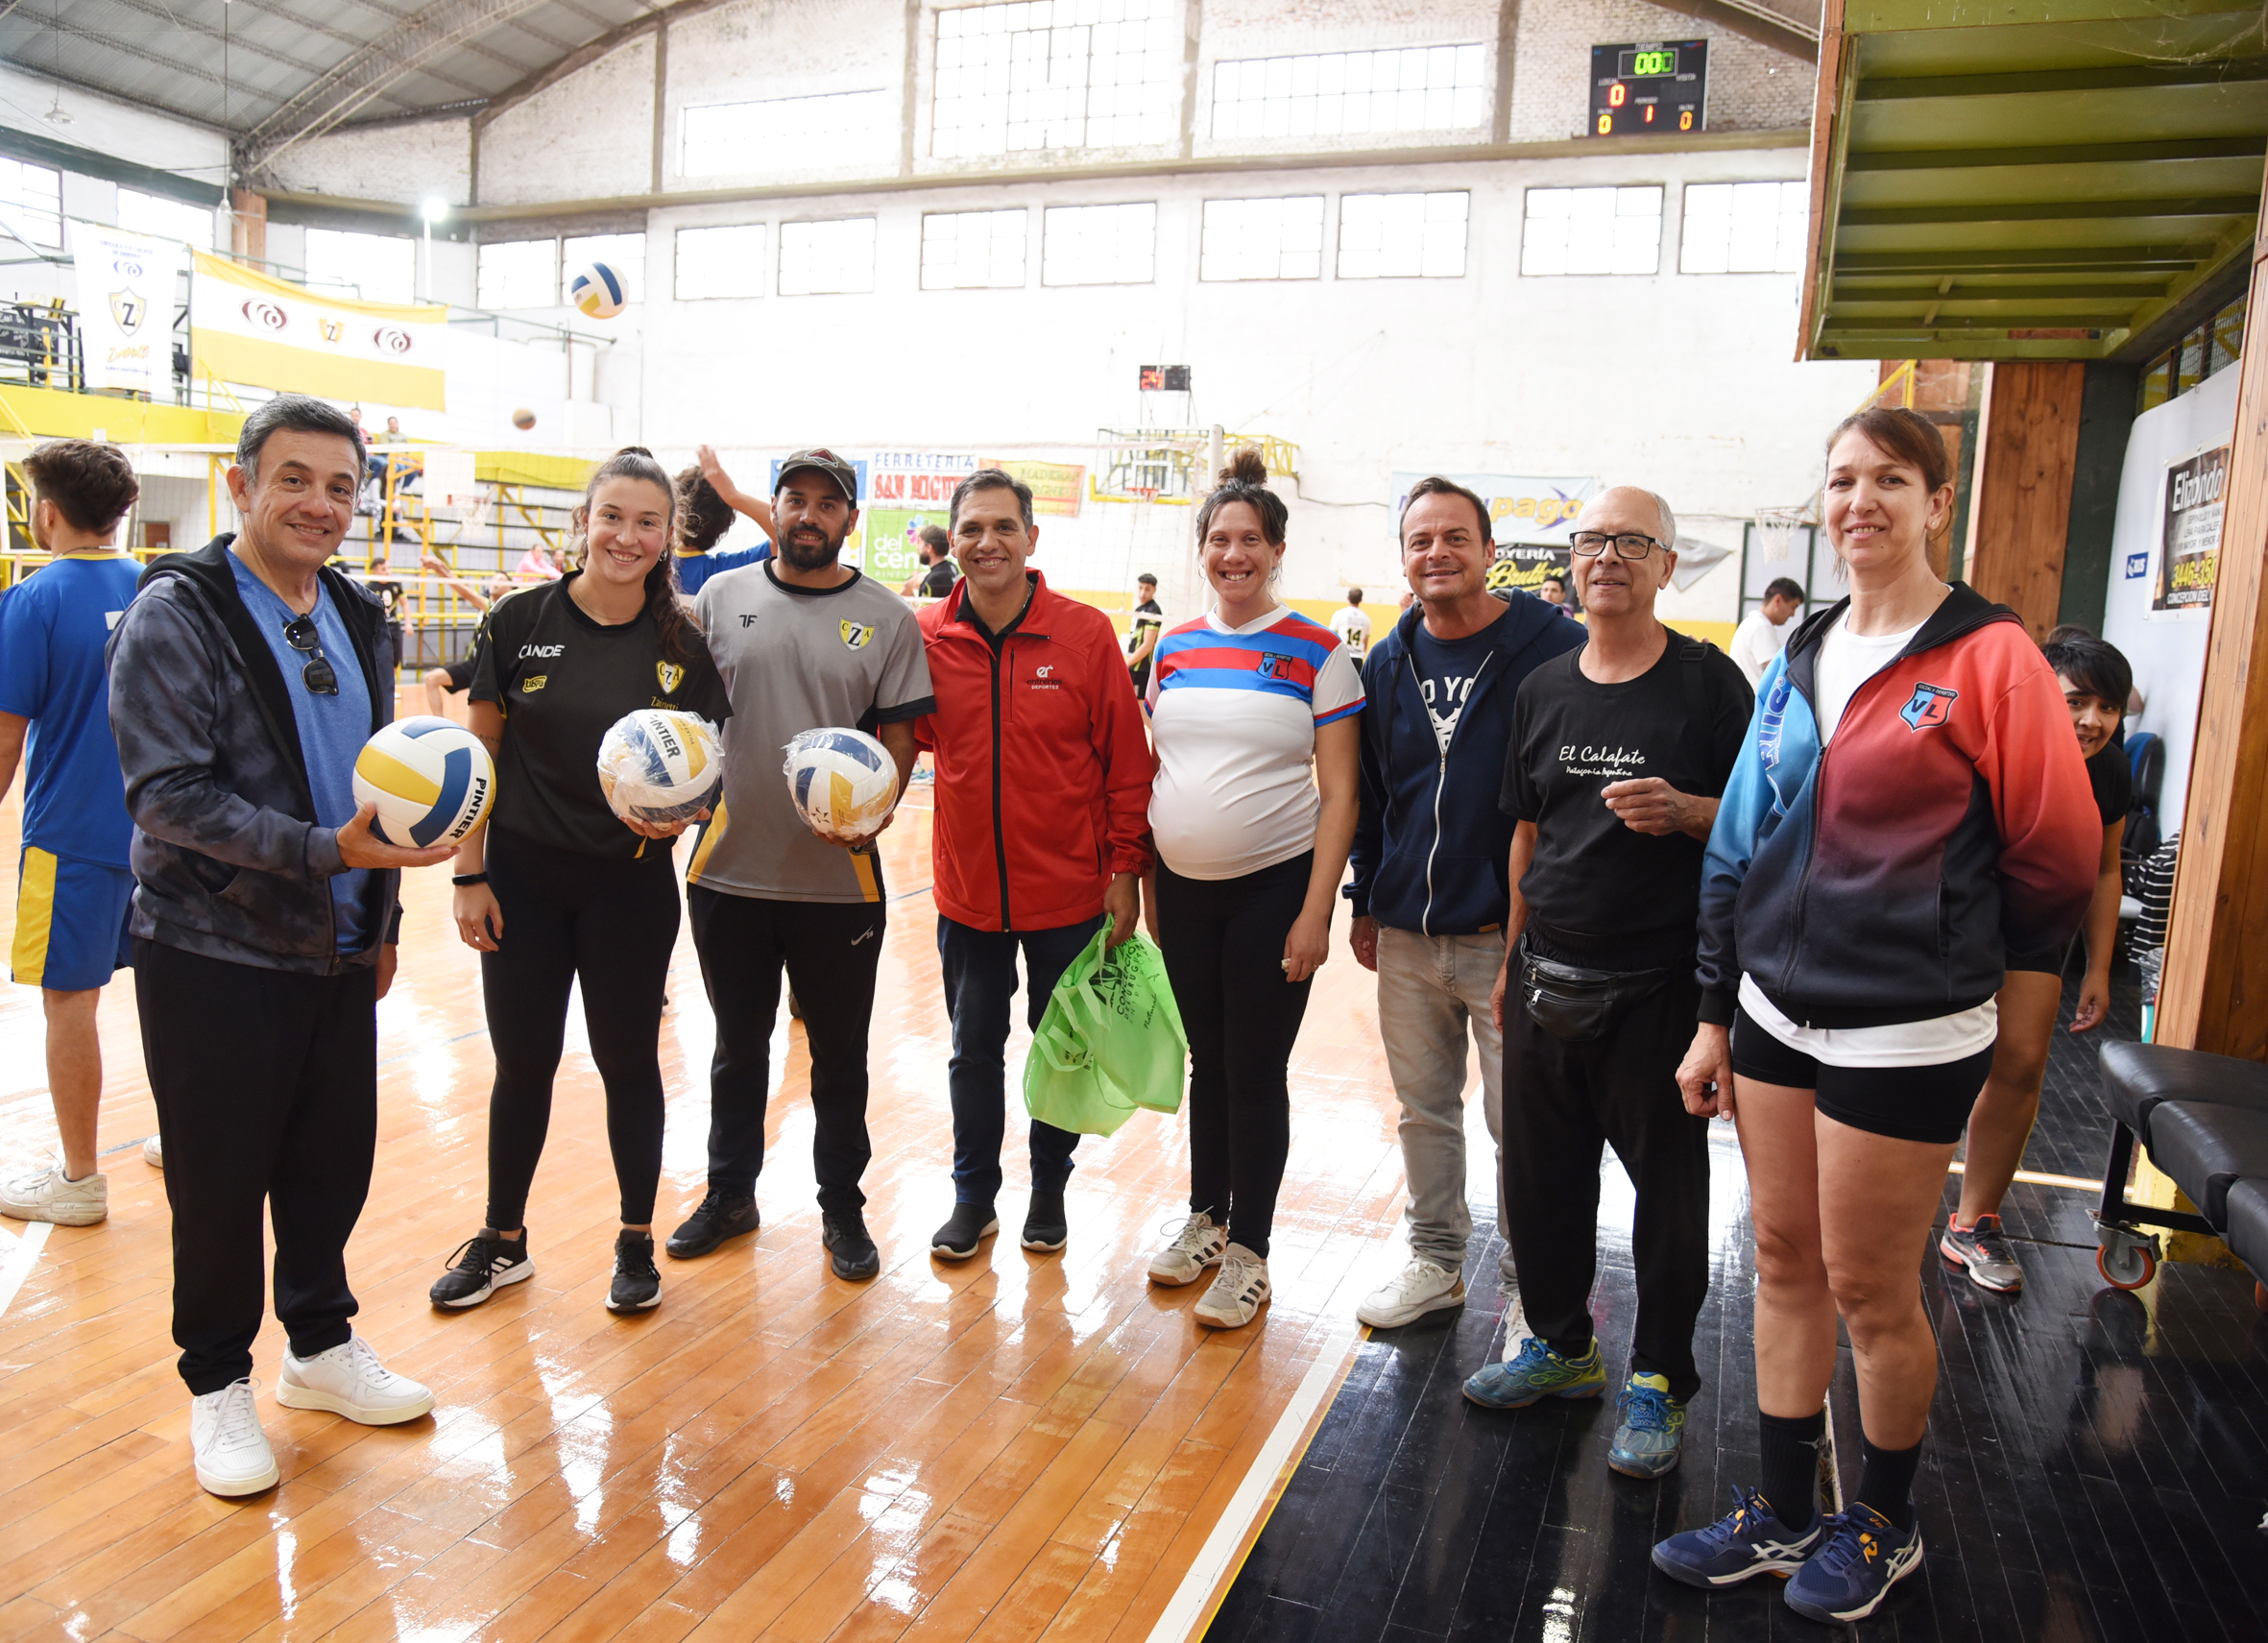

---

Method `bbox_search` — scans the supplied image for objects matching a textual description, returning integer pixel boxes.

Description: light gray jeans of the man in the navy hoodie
[1379,929,1515,1293]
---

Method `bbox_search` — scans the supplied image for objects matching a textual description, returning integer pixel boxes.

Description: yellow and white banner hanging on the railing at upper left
[188,252,449,411]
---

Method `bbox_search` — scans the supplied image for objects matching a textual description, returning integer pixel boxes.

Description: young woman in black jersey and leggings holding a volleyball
[433,447,733,1312]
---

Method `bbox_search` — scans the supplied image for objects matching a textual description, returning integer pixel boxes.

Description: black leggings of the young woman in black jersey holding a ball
[481,826,678,1232]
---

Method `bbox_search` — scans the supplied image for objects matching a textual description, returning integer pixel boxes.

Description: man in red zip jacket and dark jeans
[914,468,1157,1262]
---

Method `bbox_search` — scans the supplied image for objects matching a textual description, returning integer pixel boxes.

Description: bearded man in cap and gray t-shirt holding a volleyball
[669,449,937,1278]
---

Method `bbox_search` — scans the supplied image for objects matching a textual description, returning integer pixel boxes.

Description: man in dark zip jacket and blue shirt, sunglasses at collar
[109,395,456,1495]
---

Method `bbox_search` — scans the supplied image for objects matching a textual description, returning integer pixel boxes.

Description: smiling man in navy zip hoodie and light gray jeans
[1347,479,1583,1330]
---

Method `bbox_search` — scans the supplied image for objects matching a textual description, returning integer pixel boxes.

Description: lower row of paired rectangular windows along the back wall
[473,181,1808,308]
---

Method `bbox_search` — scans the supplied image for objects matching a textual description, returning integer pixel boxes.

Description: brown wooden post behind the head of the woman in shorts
[1964,358,2087,640]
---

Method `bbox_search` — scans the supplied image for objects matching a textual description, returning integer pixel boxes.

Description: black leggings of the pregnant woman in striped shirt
[1157,851,1315,1257]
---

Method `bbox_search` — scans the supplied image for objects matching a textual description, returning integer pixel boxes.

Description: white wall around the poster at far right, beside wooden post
[2103,370,2238,833]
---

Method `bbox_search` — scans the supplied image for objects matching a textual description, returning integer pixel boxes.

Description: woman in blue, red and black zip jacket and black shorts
[1653,408,2100,1620]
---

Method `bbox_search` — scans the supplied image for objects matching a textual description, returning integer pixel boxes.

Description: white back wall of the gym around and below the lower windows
[616,150,1875,622]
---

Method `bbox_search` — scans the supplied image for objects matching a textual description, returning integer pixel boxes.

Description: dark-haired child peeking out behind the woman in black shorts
[1937,629,2135,1293]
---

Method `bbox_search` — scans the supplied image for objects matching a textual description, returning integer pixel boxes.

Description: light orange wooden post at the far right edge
[2157,170,2268,1060]
